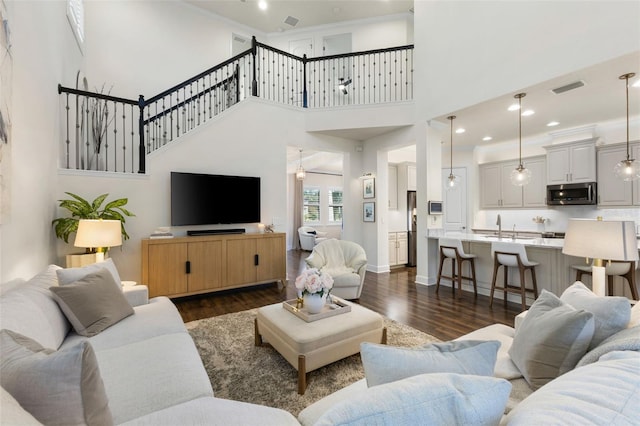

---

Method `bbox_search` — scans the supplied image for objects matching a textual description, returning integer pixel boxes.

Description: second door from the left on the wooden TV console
[188,241,223,292]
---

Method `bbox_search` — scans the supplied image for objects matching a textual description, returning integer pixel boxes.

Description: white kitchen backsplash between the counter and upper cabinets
[473,206,640,232]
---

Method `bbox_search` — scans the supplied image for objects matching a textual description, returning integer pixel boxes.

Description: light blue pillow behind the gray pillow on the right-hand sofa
[560,281,631,349]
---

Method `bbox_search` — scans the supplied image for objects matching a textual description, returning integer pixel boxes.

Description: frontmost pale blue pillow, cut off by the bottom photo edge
[315,373,511,426]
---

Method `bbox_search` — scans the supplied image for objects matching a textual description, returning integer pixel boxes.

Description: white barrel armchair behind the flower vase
[305,238,367,300]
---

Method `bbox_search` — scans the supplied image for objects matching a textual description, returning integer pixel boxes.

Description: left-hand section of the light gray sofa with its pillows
[0,264,298,425]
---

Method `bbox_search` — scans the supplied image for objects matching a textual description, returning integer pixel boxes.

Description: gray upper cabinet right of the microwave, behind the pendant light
[597,144,640,206]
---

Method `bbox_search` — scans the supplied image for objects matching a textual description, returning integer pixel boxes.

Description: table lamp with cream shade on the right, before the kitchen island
[562,219,638,296]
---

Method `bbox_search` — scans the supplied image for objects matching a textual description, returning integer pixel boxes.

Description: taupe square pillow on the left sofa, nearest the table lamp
[51,269,134,337]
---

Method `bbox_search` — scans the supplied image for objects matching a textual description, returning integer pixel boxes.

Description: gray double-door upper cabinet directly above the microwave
[545,139,596,185]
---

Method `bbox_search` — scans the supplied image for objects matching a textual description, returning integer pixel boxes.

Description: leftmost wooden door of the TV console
[149,243,189,297]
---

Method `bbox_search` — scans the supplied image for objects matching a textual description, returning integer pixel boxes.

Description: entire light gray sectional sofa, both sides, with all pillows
[0,261,640,425]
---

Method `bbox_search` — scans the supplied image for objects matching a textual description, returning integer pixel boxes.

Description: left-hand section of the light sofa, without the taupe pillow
[0,265,298,425]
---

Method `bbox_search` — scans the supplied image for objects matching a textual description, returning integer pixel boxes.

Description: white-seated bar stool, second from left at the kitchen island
[489,242,539,311]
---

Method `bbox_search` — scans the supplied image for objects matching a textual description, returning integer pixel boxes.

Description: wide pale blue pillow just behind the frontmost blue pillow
[360,340,500,387]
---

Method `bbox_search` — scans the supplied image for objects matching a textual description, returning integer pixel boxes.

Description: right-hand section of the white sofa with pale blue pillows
[298,282,640,426]
